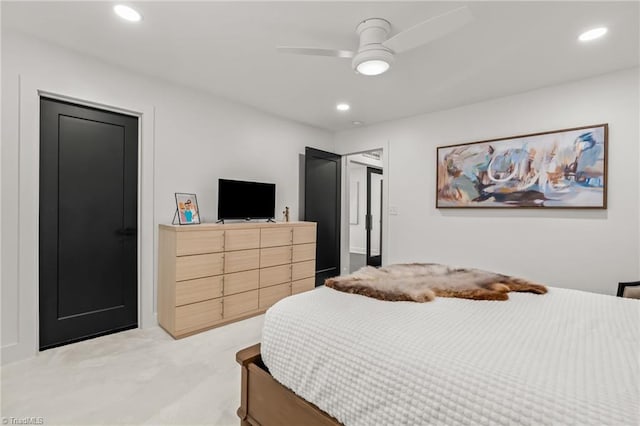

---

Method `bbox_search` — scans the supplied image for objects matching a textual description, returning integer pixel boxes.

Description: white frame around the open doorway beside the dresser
[336,147,390,275]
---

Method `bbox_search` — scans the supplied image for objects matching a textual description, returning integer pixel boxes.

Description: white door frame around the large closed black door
[2,75,157,364]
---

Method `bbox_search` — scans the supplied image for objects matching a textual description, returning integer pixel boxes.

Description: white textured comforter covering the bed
[262,287,640,425]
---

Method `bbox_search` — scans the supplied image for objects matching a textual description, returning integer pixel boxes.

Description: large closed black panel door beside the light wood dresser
[40,98,138,350]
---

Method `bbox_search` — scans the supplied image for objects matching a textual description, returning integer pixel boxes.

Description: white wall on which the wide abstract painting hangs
[336,69,640,294]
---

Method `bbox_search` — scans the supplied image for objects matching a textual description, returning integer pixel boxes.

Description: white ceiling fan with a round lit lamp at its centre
[276,6,473,75]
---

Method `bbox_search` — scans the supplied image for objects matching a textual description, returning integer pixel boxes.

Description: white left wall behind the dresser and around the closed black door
[1,30,334,362]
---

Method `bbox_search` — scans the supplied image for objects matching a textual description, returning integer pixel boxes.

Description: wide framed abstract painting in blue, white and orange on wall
[436,124,608,209]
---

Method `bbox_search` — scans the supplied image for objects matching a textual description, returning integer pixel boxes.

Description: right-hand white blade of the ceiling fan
[382,6,473,53]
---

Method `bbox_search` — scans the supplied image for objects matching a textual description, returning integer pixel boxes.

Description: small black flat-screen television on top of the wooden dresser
[218,179,276,220]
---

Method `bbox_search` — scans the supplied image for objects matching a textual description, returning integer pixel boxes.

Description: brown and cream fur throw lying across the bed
[324,263,547,302]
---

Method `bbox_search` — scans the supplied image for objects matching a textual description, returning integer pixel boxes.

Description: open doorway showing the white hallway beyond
[346,150,383,272]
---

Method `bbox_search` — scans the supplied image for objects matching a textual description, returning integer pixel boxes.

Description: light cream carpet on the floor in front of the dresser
[1,315,264,426]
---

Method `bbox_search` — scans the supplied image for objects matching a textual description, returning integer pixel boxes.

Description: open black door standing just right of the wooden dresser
[304,148,341,286]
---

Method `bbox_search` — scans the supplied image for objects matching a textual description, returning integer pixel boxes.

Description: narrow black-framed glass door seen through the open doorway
[365,167,382,266]
